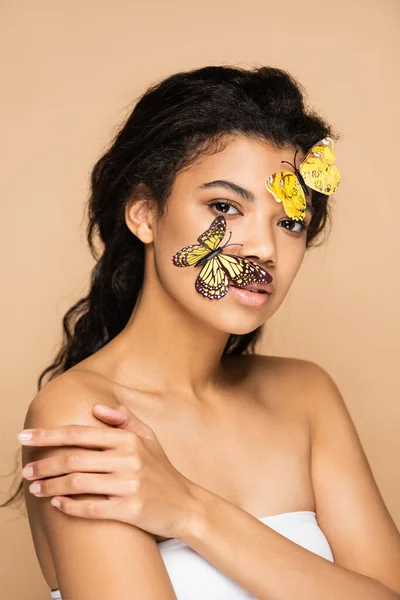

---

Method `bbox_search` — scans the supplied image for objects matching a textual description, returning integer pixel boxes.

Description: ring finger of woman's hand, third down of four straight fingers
[29,473,139,498]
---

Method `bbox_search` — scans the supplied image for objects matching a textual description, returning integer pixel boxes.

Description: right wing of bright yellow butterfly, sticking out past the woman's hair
[299,137,340,195]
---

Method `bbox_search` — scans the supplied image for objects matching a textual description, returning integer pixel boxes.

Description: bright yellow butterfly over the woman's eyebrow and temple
[265,137,340,221]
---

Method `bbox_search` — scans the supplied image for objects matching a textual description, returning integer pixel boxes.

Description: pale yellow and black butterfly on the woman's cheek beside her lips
[172,215,272,299]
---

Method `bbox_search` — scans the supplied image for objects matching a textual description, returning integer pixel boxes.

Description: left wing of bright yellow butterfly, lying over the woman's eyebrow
[265,171,306,221]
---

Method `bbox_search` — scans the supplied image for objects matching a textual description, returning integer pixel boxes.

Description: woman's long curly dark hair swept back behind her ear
[0,66,339,507]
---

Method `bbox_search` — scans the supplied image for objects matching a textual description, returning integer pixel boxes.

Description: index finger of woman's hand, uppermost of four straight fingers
[18,425,136,448]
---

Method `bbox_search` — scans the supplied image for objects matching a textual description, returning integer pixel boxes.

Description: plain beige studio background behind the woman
[0,0,400,600]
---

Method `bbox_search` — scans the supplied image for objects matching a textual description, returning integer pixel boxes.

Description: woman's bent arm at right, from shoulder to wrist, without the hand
[177,361,400,600]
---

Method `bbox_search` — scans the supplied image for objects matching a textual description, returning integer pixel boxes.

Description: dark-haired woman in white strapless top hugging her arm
[7,67,400,600]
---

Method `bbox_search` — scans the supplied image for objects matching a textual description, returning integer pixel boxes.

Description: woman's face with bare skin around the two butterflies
[146,136,311,334]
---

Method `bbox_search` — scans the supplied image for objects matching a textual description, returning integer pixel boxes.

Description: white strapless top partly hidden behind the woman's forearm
[50,510,334,600]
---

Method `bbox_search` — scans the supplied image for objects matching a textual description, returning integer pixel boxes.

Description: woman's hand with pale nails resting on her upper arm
[18,404,196,538]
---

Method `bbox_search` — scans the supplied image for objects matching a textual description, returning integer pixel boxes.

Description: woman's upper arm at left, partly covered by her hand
[23,374,176,600]
